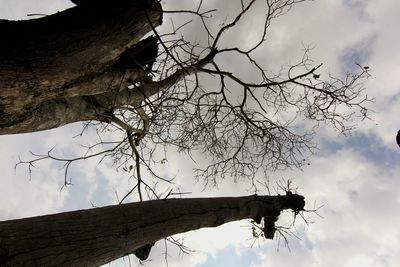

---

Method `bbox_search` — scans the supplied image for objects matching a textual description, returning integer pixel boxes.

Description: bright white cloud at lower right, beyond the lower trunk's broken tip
[250,150,400,267]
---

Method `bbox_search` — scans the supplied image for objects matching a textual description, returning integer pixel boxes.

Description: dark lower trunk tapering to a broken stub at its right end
[0,194,304,267]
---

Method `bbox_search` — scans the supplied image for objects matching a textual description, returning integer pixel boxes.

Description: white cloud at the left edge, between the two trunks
[0,131,66,220]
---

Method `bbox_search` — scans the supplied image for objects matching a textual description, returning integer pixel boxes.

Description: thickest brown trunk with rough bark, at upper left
[0,0,162,134]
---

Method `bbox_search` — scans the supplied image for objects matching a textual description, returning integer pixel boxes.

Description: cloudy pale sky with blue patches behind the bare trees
[0,0,400,267]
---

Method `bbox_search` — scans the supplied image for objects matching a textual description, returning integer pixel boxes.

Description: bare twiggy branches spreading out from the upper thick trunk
[19,0,371,219]
